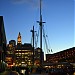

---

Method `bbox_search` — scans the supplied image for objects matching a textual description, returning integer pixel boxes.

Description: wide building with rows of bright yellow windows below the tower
[15,43,33,67]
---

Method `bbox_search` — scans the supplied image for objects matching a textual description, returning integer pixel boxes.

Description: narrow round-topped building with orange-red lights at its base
[6,40,16,67]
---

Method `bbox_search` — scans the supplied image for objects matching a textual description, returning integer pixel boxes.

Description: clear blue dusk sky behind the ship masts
[0,0,75,53]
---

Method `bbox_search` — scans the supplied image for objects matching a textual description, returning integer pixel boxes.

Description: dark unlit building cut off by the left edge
[0,16,7,61]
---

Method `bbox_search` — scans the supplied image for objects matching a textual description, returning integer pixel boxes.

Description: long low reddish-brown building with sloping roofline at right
[46,47,75,63]
